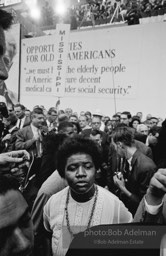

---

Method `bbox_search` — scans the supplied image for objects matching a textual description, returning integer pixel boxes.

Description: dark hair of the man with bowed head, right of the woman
[112,126,134,147]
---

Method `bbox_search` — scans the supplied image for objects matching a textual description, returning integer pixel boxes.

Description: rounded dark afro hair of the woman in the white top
[57,135,101,178]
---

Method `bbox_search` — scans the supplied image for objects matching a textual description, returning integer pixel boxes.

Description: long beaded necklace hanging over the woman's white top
[65,186,98,237]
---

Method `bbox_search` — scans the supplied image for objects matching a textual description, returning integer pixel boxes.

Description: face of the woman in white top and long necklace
[65,153,96,194]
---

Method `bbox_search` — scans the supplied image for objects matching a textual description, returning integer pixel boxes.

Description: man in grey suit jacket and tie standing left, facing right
[15,108,45,208]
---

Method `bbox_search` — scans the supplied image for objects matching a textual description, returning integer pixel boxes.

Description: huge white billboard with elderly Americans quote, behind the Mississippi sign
[21,22,166,117]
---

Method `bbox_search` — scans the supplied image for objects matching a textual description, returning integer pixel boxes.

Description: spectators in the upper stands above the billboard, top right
[76,0,166,25]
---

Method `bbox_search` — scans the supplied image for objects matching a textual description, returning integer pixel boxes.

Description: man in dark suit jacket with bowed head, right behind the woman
[113,127,156,215]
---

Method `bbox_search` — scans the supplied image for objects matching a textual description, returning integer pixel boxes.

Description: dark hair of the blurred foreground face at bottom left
[0,174,19,195]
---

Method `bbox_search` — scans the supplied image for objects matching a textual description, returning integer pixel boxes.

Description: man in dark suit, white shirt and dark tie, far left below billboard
[14,104,31,129]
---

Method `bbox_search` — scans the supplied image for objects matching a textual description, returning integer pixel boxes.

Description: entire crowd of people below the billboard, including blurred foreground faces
[0,7,166,256]
